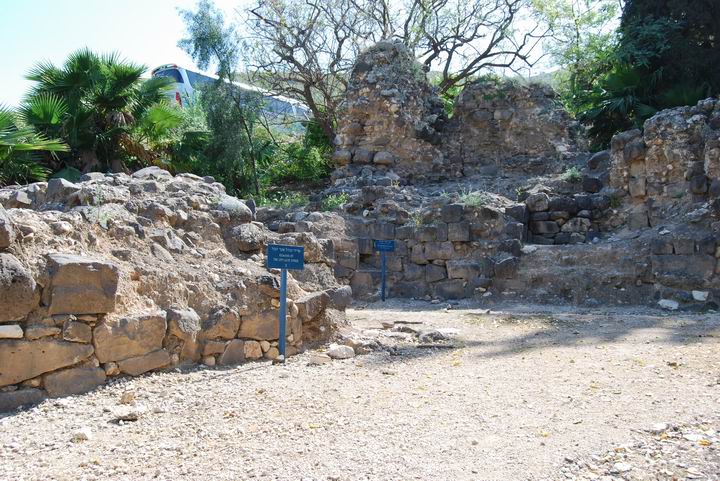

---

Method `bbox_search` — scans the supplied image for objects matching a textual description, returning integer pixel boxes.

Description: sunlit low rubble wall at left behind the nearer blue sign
[0,168,351,411]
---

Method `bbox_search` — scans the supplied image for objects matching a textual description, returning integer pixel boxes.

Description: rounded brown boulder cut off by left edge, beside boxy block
[0,254,38,322]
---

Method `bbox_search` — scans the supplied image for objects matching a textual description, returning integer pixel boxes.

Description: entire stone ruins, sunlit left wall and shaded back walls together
[0,39,720,411]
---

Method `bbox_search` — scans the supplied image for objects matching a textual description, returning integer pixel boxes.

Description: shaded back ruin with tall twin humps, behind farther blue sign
[324,43,720,309]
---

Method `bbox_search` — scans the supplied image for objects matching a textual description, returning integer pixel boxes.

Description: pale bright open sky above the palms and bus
[0,0,247,106]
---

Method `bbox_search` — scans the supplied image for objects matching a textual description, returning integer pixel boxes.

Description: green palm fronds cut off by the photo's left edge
[0,105,69,185]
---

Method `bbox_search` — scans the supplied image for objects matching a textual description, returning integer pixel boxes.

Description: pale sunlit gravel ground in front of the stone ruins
[0,301,720,481]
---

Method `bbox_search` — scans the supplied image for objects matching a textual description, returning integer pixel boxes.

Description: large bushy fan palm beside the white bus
[21,49,179,172]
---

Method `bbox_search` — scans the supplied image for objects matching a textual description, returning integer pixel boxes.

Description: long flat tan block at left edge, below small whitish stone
[0,340,93,386]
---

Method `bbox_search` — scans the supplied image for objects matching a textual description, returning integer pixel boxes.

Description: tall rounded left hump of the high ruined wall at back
[334,42,446,182]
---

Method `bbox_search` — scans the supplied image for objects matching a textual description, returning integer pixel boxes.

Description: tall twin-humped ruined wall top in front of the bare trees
[334,42,583,185]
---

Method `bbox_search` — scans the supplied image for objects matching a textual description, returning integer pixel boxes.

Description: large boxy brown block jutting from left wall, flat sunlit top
[45,254,118,314]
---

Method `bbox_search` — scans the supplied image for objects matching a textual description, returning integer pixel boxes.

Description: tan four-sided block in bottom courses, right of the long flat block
[93,311,167,362]
